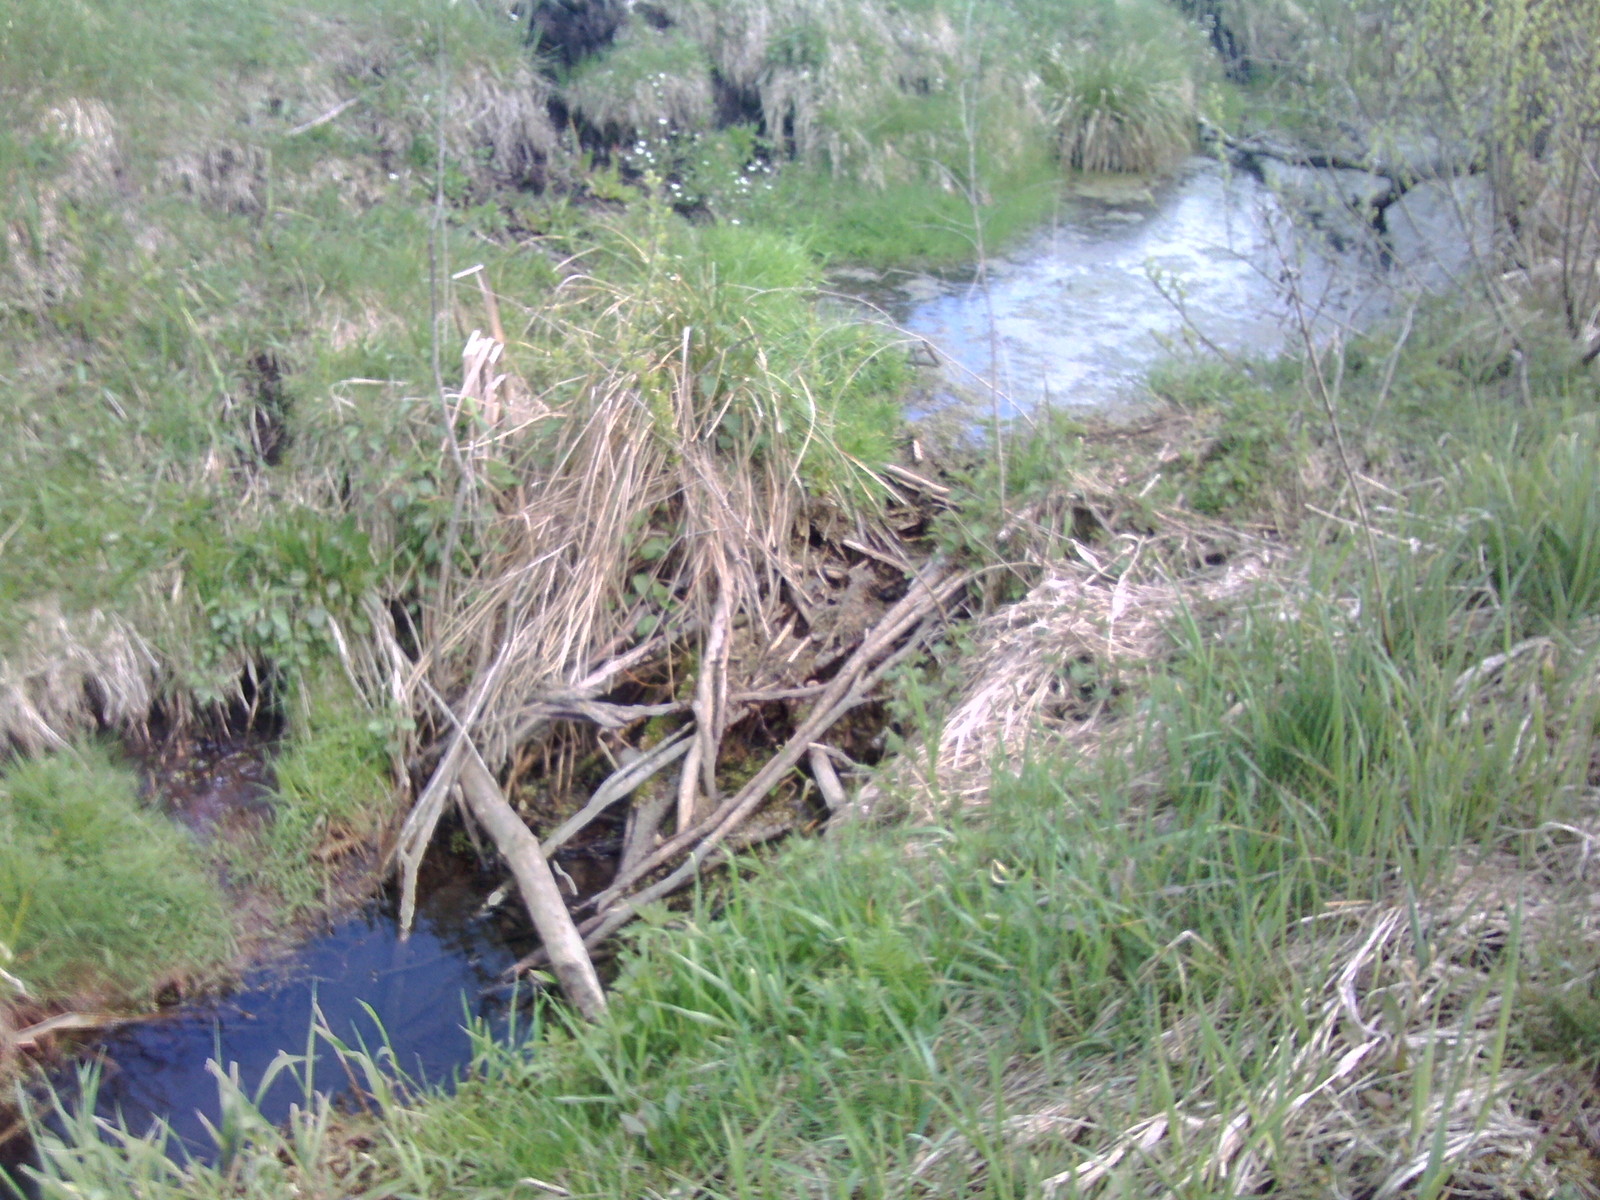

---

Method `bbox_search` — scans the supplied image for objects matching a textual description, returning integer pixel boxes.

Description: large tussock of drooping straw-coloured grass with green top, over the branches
[369,226,921,928]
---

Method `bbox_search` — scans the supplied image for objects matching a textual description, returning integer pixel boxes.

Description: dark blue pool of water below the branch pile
[0,859,531,1195]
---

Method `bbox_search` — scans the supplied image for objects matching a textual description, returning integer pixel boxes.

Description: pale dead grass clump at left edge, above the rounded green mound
[0,603,163,754]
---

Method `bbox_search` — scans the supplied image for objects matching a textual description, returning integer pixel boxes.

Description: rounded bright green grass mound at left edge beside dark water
[0,747,234,1005]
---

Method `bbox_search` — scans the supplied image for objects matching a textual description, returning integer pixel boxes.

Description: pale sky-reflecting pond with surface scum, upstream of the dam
[866,158,1483,421]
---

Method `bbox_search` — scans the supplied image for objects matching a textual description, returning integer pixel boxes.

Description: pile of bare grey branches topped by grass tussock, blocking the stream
[355,249,970,1018]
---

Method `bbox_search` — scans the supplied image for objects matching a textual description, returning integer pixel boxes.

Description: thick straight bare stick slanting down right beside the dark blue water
[459,752,605,1021]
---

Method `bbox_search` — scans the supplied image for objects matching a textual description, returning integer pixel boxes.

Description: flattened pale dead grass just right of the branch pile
[851,416,1278,816]
